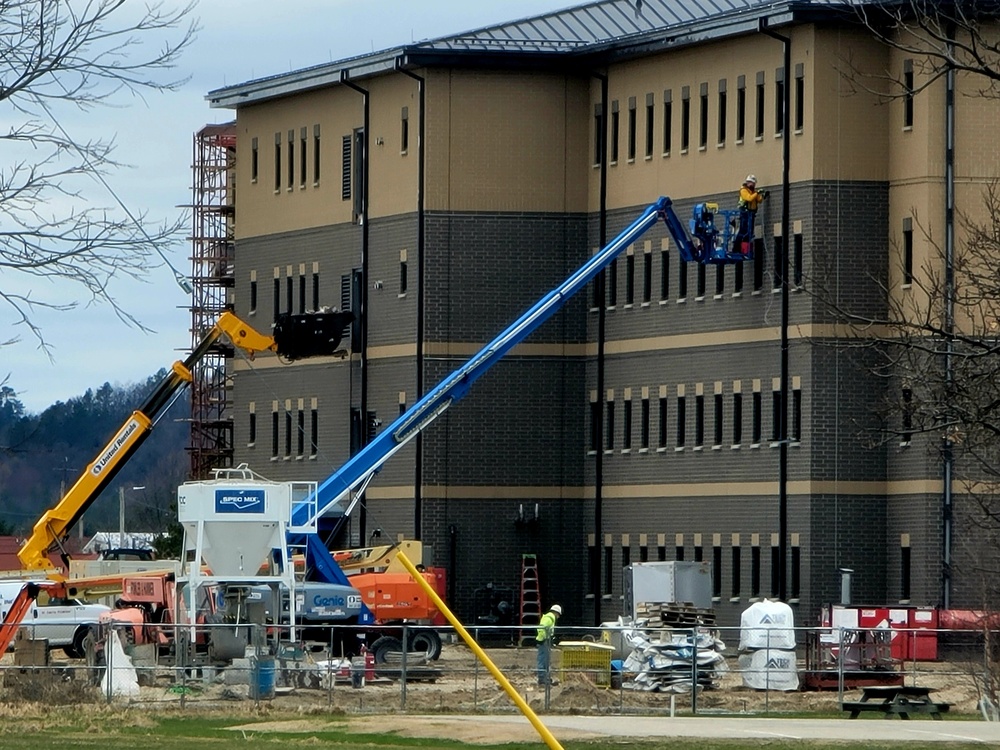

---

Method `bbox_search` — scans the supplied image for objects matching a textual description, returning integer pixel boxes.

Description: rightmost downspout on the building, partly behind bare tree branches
[941,29,955,609]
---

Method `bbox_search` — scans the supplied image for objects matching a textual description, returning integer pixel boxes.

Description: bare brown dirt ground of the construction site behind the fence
[0,644,978,728]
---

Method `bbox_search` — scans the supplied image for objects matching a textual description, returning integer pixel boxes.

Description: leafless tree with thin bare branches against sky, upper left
[0,0,197,348]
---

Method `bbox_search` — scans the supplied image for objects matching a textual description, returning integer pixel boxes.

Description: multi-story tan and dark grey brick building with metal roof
[201,0,997,624]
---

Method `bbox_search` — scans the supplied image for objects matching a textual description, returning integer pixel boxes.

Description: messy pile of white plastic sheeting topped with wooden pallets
[619,602,728,693]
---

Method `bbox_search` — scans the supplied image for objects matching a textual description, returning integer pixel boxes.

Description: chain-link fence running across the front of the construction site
[0,625,1000,720]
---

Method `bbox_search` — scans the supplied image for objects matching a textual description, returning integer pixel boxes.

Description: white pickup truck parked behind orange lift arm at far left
[0,580,111,659]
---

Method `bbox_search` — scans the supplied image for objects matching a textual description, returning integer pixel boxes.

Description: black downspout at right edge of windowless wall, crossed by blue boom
[590,73,612,627]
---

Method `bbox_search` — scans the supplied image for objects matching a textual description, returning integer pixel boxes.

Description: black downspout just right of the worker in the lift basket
[758,18,797,602]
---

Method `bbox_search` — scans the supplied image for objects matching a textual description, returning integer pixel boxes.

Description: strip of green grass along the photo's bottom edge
[0,704,982,750]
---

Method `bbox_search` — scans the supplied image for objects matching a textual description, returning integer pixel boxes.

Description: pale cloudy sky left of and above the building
[0,0,582,413]
